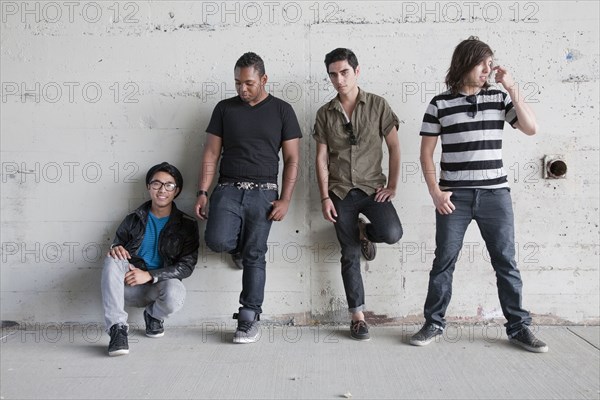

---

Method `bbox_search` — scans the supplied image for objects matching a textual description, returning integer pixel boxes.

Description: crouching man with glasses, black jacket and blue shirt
[101,162,199,356]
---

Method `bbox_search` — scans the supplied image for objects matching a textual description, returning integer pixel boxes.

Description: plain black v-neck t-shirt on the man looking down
[206,94,302,183]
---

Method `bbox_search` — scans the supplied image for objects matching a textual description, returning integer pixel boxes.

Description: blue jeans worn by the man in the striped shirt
[424,188,531,336]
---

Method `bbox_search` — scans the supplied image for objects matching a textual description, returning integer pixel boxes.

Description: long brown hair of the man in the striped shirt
[446,36,494,94]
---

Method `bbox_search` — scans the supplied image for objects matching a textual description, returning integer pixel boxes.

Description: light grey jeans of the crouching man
[101,256,186,332]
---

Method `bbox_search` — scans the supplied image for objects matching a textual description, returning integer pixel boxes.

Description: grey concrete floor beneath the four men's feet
[0,323,600,399]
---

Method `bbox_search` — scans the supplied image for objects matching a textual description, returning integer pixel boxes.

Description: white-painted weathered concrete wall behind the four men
[0,1,599,325]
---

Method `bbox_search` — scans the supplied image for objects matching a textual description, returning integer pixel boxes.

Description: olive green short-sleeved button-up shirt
[313,89,399,199]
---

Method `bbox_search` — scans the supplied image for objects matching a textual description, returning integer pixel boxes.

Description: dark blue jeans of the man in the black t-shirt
[204,186,278,314]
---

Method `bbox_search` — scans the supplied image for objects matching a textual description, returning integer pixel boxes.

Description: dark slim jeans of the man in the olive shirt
[329,189,403,313]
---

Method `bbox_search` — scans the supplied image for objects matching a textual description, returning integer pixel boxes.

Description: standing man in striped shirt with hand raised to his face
[410,36,548,353]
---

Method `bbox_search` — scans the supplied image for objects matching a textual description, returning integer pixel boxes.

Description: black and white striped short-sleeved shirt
[421,89,517,189]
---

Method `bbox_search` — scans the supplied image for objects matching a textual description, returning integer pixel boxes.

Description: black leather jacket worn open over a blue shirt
[111,201,200,282]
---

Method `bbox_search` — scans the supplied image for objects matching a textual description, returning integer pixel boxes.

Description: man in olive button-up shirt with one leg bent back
[313,48,402,340]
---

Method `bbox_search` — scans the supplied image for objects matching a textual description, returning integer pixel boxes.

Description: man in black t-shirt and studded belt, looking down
[195,53,302,343]
